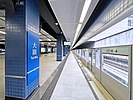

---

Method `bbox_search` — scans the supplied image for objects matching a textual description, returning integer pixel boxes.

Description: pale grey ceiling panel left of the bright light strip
[49,0,85,41]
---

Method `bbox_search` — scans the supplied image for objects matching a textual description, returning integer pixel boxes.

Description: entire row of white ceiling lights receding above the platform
[74,0,92,41]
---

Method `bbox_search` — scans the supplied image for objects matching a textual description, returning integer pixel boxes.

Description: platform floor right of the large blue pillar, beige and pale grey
[27,52,113,100]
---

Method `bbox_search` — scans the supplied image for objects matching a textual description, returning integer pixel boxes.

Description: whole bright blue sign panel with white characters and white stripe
[27,32,40,84]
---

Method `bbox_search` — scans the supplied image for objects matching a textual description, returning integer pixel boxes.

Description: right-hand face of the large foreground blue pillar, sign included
[26,0,40,96]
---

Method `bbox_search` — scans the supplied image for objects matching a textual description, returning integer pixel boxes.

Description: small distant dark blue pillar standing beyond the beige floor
[57,35,63,61]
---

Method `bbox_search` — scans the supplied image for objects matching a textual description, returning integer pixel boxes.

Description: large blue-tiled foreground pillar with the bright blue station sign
[5,0,40,99]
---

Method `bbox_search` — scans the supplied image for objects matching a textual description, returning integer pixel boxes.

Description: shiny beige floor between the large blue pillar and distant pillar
[39,53,61,86]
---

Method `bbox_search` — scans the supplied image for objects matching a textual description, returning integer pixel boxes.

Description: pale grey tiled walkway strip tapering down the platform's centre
[51,53,95,100]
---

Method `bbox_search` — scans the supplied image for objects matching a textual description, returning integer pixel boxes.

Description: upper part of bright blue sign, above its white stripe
[28,32,40,72]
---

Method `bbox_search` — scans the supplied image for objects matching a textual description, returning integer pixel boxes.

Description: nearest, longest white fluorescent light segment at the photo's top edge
[79,0,92,23]
